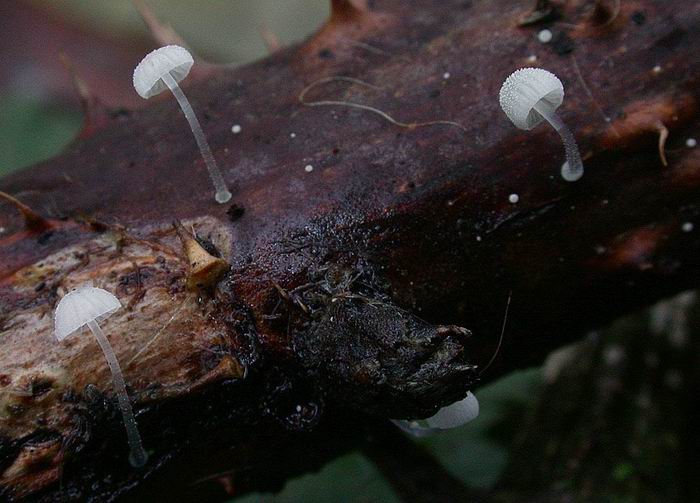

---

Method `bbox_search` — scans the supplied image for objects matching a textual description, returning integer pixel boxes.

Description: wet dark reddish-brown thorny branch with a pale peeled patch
[0,0,700,501]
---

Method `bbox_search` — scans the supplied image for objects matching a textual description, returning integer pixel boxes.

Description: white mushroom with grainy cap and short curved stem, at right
[499,68,583,182]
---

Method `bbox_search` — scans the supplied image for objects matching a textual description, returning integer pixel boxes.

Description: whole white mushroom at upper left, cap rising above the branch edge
[134,45,231,204]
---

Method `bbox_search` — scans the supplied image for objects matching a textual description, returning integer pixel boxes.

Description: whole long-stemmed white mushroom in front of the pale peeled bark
[54,285,148,467]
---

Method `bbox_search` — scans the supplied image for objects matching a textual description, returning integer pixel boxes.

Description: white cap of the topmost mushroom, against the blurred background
[134,45,194,99]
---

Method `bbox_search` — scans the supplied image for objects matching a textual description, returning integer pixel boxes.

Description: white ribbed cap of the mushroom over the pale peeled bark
[54,286,122,341]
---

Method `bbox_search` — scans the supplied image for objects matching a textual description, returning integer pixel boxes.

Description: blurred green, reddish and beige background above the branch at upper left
[0,0,330,175]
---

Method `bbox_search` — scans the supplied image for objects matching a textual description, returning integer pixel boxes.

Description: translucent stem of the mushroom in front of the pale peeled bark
[87,320,148,468]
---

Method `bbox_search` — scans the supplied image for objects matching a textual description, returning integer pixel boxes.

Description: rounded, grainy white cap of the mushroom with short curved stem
[499,68,564,130]
